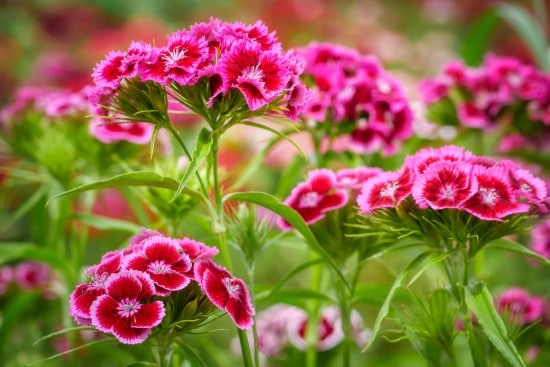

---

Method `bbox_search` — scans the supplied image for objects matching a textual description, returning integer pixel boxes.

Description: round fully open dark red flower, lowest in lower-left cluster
[90,271,165,344]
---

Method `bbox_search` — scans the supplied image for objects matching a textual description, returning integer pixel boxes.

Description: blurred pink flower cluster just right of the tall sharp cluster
[299,43,413,154]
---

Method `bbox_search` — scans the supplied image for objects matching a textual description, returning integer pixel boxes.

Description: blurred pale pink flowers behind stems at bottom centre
[235,303,370,358]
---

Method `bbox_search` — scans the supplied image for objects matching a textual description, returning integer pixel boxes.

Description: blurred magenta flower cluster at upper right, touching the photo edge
[419,55,550,150]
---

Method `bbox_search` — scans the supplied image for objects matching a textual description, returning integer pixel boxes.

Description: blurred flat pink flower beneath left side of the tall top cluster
[90,122,155,144]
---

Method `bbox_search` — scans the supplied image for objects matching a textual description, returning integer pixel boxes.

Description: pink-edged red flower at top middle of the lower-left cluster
[124,236,191,296]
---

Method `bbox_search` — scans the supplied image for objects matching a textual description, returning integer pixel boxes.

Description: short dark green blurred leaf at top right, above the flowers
[462,10,499,66]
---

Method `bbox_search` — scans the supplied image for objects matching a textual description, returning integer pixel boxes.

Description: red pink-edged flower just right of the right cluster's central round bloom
[463,166,529,221]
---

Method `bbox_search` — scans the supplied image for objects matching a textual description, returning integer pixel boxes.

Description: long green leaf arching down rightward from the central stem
[223,191,351,290]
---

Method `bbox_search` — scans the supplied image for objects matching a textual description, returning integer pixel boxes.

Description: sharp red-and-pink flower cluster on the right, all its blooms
[357,146,547,221]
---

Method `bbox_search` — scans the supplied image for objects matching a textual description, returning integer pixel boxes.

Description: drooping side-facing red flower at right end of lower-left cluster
[195,260,255,329]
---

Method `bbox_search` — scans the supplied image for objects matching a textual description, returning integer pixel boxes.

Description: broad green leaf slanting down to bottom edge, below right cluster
[465,283,525,367]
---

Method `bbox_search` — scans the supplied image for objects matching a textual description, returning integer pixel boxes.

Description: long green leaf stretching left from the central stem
[46,171,178,205]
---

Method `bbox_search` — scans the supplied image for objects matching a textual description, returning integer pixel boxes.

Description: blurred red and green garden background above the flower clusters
[0,0,546,105]
